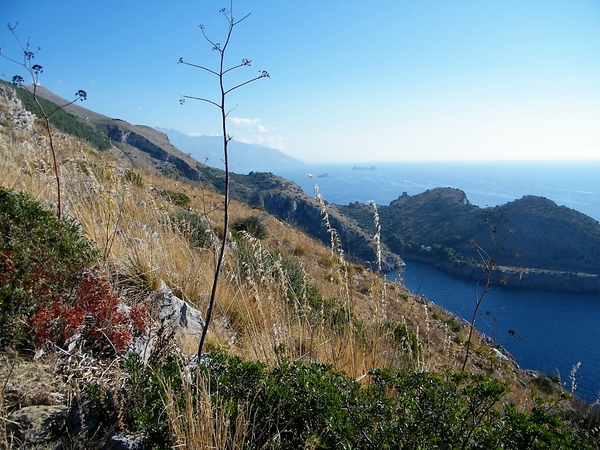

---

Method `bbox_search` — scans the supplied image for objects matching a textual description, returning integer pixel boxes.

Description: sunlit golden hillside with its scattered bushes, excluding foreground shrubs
[0,82,596,448]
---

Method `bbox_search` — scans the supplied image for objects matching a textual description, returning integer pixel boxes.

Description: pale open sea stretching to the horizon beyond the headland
[276,161,600,220]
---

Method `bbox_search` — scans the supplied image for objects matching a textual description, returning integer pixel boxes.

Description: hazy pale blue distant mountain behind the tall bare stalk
[156,127,303,174]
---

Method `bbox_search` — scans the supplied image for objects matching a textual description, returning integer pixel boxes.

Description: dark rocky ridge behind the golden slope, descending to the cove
[22,88,402,270]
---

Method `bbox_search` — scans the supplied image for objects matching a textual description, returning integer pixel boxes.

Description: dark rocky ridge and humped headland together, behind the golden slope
[18,84,600,292]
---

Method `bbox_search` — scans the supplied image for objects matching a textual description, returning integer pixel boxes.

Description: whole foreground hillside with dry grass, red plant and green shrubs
[0,85,595,448]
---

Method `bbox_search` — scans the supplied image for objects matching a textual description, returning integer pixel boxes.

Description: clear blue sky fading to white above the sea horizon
[0,0,600,163]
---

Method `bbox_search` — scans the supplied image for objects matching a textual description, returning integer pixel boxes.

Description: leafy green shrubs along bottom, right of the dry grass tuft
[198,354,592,449]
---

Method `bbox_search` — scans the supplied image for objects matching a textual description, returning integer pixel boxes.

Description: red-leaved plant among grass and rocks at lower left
[29,270,148,354]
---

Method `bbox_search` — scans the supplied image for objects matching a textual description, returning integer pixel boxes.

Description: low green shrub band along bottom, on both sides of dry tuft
[115,353,594,449]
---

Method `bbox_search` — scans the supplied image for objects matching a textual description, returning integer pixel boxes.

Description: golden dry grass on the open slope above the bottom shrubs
[0,121,506,370]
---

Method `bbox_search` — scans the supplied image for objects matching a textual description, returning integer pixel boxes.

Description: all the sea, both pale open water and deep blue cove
[275,161,600,402]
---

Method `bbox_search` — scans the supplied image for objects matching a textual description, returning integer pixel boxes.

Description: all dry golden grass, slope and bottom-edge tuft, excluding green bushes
[0,90,544,442]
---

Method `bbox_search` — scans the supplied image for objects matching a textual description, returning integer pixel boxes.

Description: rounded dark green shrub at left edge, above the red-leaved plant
[0,188,98,348]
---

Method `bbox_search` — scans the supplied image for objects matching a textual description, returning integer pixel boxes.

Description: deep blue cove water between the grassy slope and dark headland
[387,260,600,402]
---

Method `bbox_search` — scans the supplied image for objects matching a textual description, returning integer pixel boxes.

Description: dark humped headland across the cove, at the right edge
[340,188,600,293]
